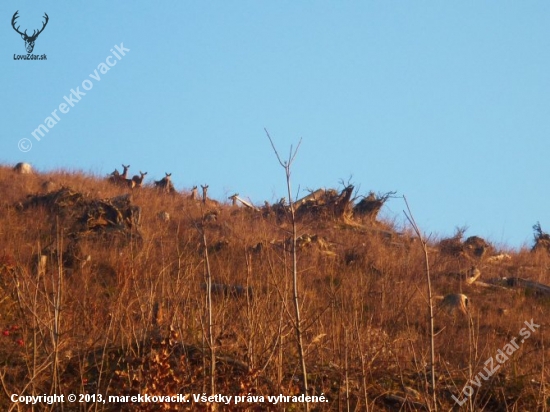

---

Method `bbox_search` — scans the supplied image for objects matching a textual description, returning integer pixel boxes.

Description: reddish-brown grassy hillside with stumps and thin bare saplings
[0,166,550,411]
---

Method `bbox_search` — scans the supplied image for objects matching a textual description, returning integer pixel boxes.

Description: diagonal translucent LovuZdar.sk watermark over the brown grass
[451,319,540,406]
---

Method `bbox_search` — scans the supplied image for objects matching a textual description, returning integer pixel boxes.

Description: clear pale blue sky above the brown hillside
[0,0,550,247]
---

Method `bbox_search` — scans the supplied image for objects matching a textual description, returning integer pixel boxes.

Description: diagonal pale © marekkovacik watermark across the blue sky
[17,43,130,152]
